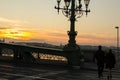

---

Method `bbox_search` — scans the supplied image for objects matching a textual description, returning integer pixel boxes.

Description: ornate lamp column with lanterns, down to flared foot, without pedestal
[55,0,90,66]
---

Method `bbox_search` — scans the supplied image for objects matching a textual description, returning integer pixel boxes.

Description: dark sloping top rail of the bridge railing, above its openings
[0,42,64,56]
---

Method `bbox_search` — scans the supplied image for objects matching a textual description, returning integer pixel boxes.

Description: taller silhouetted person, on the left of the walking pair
[94,46,105,78]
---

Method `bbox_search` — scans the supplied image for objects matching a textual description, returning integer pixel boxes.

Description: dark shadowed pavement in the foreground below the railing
[0,62,120,80]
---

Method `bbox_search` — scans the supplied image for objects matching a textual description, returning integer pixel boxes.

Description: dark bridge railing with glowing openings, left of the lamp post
[0,43,67,64]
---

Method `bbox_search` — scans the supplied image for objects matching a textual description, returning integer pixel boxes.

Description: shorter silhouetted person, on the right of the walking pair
[105,49,116,80]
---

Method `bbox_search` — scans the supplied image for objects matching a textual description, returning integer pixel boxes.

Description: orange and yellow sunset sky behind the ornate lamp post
[0,0,120,46]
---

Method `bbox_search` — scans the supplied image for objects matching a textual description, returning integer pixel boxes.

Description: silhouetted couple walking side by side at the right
[94,46,116,78]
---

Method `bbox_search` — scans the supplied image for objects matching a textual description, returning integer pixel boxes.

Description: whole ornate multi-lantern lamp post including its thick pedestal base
[55,0,90,65]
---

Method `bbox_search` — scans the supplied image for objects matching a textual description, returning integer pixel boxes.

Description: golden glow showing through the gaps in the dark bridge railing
[2,53,67,61]
